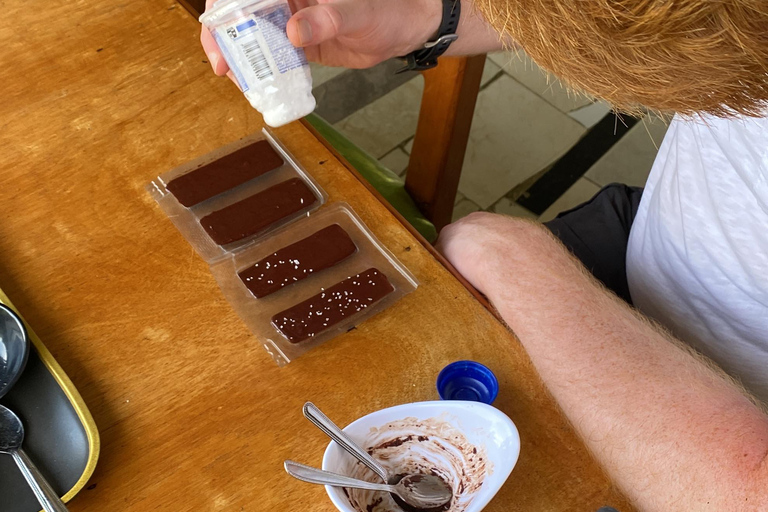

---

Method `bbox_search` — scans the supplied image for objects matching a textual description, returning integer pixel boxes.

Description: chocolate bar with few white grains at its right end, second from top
[200,178,317,245]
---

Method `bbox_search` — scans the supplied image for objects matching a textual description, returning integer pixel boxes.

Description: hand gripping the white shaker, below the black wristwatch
[200,0,442,75]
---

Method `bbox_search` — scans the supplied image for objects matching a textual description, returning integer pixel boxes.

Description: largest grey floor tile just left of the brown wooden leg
[334,77,424,158]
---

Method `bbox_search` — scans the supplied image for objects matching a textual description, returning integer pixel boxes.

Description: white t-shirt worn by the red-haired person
[627,113,768,403]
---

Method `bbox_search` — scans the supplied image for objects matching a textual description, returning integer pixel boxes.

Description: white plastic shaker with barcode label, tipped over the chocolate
[200,0,315,127]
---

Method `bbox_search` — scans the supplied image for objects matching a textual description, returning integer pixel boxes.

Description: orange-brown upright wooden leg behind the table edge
[405,55,485,230]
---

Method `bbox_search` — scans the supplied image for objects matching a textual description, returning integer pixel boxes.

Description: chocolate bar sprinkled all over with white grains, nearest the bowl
[272,268,394,343]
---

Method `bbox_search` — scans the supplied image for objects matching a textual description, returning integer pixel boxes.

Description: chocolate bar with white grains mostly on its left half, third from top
[238,224,357,299]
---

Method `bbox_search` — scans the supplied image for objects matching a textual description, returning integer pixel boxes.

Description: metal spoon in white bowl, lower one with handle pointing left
[285,460,453,510]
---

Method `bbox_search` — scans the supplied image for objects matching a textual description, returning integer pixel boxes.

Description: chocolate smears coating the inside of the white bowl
[341,416,493,512]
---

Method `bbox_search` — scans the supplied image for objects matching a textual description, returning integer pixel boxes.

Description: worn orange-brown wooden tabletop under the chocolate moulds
[0,0,628,512]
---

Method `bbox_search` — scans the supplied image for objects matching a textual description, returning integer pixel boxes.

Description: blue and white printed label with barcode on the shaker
[219,4,307,88]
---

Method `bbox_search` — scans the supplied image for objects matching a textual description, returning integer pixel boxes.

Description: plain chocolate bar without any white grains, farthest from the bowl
[166,140,283,207]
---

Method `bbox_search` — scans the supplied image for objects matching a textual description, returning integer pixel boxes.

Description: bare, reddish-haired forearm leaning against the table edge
[440,215,768,511]
